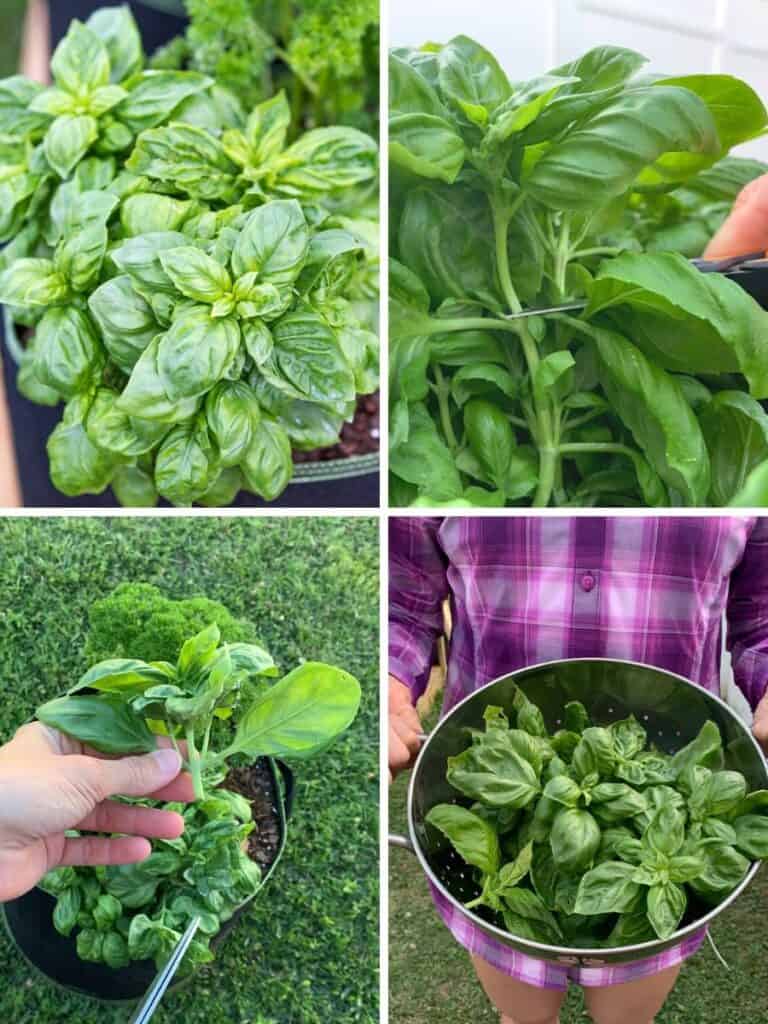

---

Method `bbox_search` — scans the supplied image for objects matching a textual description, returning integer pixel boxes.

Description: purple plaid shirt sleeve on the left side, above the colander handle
[389,516,449,703]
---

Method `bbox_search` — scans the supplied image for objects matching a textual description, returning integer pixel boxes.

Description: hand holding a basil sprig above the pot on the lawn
[0,722,194,901]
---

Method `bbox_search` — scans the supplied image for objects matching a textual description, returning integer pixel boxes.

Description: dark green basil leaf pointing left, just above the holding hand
[35,695,158,754]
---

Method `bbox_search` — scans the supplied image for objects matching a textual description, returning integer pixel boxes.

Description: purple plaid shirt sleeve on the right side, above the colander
[727,518,768,711]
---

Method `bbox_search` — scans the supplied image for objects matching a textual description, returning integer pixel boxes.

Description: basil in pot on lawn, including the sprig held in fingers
[37,626,360,971]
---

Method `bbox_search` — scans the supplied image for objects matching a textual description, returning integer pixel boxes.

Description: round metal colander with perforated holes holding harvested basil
[391,658,768,967]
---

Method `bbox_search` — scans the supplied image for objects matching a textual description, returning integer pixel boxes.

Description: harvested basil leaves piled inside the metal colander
[426,690,768,948]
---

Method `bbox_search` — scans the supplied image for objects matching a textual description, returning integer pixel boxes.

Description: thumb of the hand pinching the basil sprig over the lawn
[71,750,186,807]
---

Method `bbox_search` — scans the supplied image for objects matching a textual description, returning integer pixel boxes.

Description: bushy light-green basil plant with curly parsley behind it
[0,7,378,506]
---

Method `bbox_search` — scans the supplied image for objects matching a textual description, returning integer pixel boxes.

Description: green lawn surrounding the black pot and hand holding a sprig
[0,518,379,1024]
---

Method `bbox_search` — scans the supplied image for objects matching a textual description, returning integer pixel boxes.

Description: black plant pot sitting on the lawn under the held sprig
[2,758,293,1001]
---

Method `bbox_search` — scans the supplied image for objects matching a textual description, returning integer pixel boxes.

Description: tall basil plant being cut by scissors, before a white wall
[389,36,768,507]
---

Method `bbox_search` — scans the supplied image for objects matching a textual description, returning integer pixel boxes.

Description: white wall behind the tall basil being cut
[389,0,768,161]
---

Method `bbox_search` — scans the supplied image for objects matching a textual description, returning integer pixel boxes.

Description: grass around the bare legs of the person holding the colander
[389,749,768,1024]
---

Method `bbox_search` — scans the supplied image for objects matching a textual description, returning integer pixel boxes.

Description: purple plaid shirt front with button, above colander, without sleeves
[437,517,751,711]
